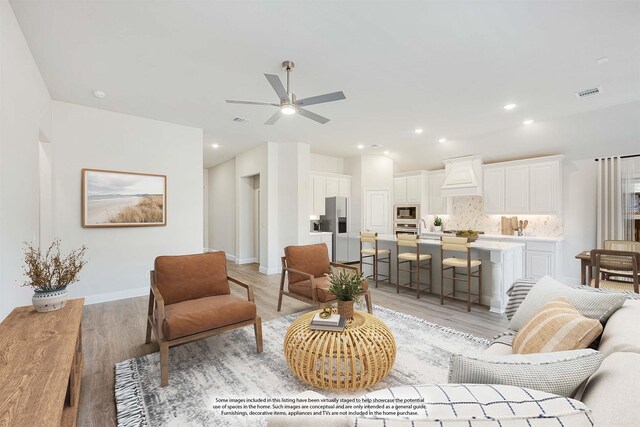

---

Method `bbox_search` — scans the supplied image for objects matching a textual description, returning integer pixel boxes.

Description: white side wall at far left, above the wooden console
[0,0,52,319]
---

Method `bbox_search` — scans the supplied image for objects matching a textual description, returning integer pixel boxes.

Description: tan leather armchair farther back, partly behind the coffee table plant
[278,243,373,313]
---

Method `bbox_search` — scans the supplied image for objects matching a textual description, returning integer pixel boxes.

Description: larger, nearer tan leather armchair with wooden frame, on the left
[145,252,262,387]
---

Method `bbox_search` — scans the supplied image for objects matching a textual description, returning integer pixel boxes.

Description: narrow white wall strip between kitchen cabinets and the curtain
[562,158,598,283]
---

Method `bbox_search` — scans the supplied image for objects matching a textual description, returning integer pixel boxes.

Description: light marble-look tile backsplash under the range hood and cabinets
[430,196,564,237]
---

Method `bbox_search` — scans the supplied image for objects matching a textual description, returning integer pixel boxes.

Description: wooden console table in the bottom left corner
[0,298,84,426]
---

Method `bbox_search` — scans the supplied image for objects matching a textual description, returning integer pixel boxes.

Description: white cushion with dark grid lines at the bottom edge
[350,384,593,427]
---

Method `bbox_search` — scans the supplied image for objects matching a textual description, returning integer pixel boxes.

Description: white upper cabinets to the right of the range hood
[483,156,563,215]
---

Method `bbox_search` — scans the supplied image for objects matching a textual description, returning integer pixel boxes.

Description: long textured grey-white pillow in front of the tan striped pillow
[449,349,604,397]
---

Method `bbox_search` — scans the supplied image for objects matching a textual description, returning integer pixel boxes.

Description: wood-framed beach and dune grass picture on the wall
[82,169,167,227]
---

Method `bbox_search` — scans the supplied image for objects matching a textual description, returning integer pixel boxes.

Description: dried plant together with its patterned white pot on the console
[22,239,87,312]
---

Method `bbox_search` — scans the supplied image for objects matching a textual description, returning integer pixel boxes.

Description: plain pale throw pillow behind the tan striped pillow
[509,276,627,331]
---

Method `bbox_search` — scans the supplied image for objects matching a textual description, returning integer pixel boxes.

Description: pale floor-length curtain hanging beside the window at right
[596,157,625,248]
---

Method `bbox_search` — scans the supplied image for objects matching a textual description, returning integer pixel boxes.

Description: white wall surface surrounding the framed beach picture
[53,101,203,303]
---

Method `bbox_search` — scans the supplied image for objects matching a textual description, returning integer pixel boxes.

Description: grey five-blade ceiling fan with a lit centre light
[227,61,347,125]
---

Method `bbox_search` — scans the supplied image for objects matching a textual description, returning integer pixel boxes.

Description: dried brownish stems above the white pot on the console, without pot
[22,239,87,292]
